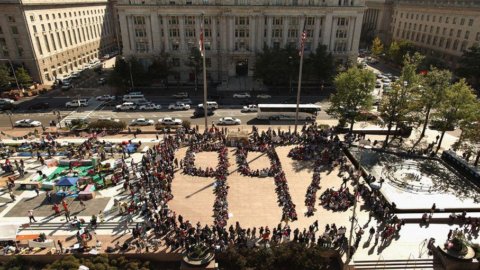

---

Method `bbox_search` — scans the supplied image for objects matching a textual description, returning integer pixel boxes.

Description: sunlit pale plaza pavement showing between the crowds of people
[0,123,472,268]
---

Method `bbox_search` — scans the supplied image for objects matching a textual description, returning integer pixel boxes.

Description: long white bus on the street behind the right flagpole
[257,104,321,121]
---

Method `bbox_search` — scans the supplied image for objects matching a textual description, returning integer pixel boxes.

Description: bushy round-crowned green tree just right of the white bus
[327,67,375,131]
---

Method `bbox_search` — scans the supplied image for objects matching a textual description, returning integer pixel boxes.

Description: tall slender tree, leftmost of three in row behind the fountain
[379,53,423,147]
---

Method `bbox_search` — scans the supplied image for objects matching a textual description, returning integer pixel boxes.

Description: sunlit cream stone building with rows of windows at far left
[0,0,117,84]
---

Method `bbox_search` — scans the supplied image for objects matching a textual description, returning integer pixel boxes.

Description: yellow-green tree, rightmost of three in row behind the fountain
[434,79,478,152]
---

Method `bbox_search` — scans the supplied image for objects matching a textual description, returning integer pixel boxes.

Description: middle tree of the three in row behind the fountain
[419,68,452,140]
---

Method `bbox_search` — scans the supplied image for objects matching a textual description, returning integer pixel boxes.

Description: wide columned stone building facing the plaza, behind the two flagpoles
[117,0,365,82]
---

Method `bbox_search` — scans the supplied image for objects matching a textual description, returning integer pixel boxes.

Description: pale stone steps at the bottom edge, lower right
[353,258,444,270]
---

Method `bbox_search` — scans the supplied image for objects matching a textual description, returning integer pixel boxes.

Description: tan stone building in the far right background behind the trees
[390,0,480,66]
